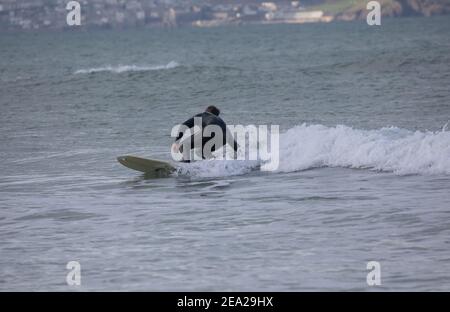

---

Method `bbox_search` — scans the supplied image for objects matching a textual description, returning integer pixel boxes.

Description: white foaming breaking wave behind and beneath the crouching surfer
[173,124,450,177]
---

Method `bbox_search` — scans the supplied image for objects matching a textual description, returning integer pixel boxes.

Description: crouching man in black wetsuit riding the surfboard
[172,105,238,162]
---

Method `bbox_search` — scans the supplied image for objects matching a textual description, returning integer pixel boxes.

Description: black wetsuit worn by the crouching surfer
[175,112,238,161]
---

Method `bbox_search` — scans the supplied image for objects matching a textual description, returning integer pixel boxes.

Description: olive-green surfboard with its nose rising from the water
[117,155,176,177]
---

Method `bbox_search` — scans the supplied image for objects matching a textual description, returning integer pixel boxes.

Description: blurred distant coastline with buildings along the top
[0,0,450,31]
